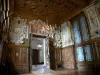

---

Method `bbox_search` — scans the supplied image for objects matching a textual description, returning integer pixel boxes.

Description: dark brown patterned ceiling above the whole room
[15,0,92,23]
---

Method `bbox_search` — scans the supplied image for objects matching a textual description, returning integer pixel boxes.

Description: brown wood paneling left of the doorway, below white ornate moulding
[8,47,29,73]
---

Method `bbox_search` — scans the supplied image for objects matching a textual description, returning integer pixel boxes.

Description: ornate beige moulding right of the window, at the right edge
[84,5,100,38]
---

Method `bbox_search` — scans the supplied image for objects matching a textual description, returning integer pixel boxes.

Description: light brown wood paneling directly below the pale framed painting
[62,46,75,69]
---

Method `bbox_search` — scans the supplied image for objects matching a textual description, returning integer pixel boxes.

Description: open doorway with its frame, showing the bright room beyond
[30,34,50,71]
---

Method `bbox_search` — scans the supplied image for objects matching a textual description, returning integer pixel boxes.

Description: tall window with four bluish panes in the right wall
[71,13,92,61]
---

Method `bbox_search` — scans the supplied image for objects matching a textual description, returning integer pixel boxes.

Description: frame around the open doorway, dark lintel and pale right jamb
[29,34,50,71]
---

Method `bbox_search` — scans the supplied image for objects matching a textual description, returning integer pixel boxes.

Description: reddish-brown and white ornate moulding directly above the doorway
[29,20,54,38]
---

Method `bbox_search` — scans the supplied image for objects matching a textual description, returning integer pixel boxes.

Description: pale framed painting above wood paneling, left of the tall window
[61,21,73,47]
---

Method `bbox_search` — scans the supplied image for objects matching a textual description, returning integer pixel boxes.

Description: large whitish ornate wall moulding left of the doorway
[9,16,28,44]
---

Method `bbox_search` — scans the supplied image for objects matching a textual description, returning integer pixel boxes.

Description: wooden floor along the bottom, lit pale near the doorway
[19,69,96,75]
